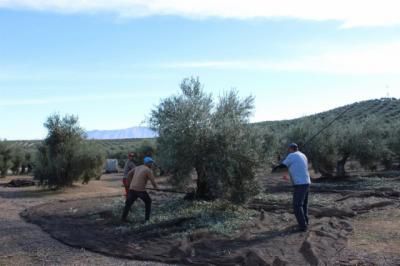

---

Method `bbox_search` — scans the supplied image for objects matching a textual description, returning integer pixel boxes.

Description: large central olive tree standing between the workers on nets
[150,78,256,201]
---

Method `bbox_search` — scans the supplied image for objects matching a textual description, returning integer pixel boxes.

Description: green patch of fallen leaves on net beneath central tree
[113,199,259,236]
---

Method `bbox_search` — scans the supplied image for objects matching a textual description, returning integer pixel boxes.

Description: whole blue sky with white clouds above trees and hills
[0,0,400,139]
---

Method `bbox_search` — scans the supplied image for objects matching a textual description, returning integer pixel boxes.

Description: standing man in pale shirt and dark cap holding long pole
[272,143,311,232]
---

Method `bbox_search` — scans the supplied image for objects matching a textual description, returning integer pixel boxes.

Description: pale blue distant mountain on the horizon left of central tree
[86,127,157,139]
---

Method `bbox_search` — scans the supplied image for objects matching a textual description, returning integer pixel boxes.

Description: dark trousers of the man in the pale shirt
[293,185,310,229]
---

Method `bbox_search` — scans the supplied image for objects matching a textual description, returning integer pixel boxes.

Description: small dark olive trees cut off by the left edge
[0,141,33,177]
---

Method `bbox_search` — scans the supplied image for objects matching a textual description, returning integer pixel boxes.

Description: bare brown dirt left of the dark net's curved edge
[0,175,170,266]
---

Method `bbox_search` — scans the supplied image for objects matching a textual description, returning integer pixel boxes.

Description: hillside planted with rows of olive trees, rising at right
[254,98,400,130]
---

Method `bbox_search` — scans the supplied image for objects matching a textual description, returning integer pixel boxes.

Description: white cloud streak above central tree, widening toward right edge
[160,42,400,75]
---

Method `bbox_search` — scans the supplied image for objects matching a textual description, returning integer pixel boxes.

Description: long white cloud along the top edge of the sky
[0,0,400,27]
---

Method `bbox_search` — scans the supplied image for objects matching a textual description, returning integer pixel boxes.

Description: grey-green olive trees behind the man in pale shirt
[281,116,400,177]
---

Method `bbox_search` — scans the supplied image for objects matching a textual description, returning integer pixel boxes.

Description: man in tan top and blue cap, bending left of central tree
[121,157,158,222]
